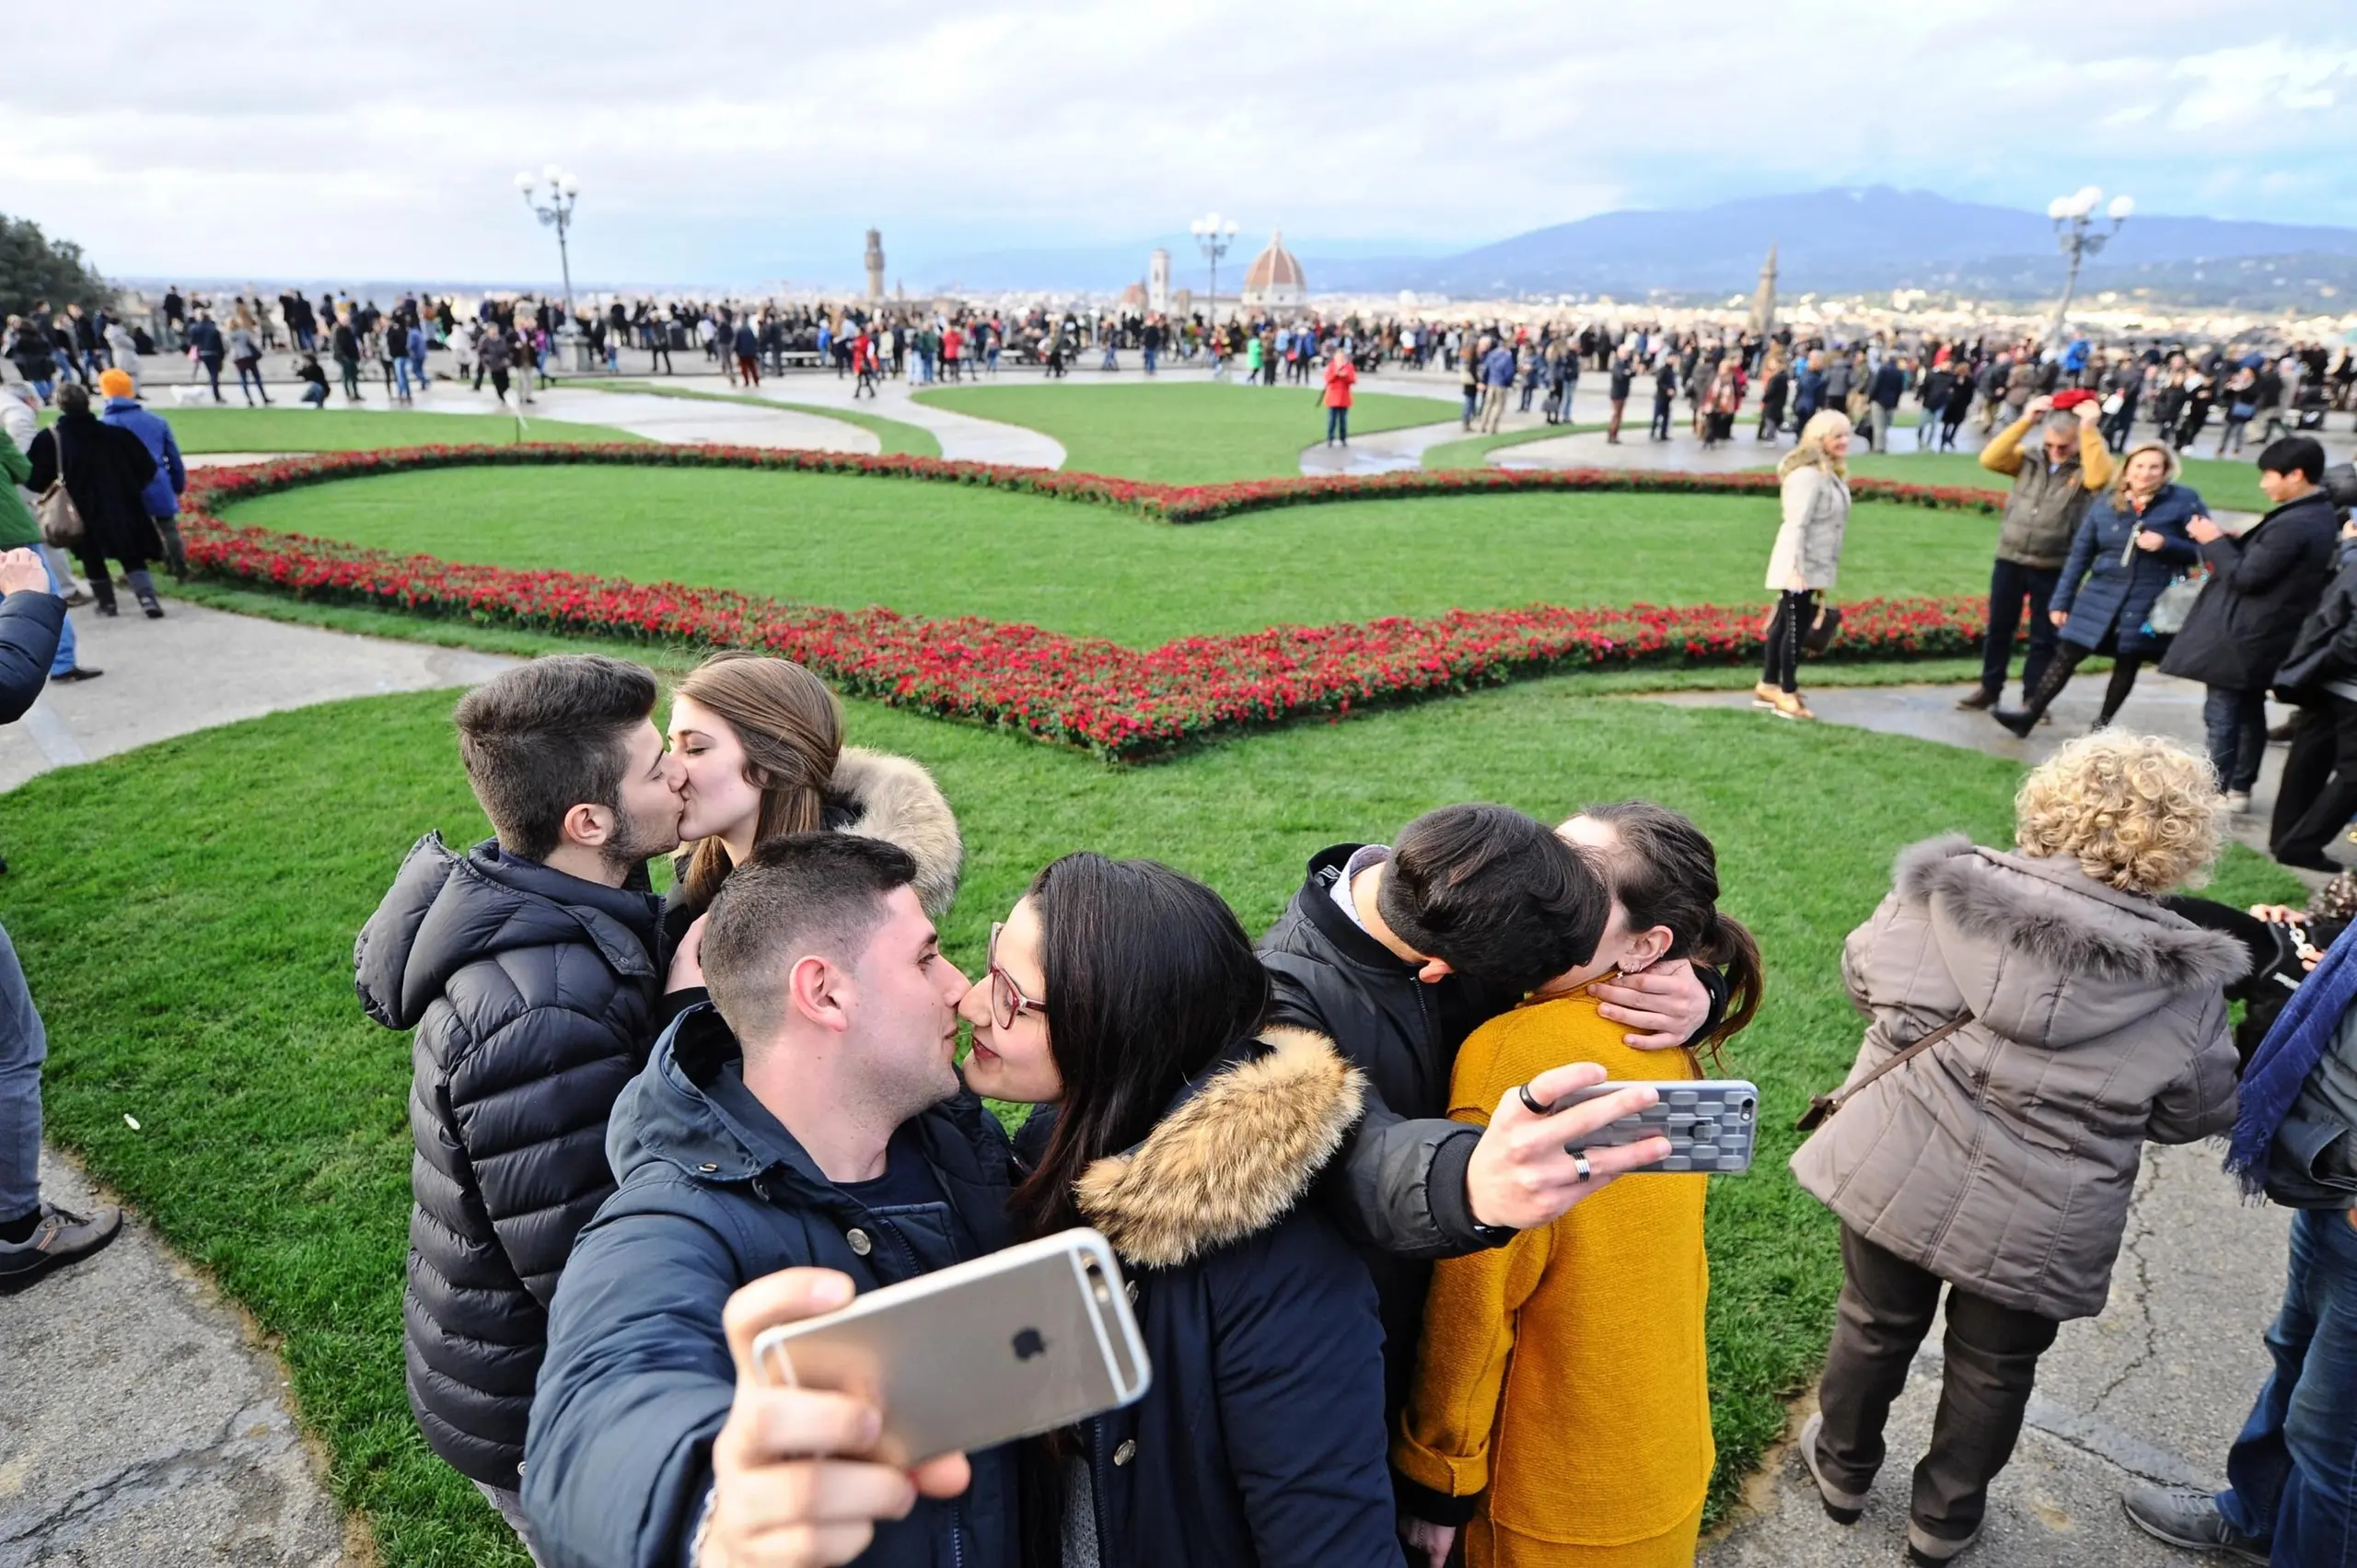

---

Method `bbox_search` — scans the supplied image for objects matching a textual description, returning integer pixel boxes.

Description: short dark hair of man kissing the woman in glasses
[700,832,917,1050]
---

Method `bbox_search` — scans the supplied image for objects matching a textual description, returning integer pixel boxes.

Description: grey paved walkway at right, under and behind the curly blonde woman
[1647,672,2291,1568]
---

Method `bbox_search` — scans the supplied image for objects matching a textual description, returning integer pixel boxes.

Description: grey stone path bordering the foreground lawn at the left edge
[0,598,516,1568]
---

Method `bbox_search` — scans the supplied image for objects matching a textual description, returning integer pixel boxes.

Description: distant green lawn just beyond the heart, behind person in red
[917,382,1457,483]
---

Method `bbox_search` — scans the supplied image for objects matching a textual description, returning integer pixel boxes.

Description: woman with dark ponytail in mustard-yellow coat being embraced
[1390,802,1760,1568]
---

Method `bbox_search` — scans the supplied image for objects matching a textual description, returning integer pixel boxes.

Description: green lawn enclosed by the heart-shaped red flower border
[228,461,1996,646]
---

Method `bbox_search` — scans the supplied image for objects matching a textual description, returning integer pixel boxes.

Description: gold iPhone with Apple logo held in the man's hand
[752,1228,1153,1467]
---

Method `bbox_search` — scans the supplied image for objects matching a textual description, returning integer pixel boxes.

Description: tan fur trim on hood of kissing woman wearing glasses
[1074,1028,1367,1269]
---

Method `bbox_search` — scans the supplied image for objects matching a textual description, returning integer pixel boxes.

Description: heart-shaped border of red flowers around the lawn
[181,446,2001,760]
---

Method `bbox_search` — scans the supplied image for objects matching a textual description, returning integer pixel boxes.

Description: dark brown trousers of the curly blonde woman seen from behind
[1817,1226,2060,1539]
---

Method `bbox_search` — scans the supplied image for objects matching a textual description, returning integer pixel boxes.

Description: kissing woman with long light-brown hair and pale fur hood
[662,651,964,966]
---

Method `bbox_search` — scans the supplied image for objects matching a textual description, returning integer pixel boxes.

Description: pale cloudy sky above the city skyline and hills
[0,0,2357,283]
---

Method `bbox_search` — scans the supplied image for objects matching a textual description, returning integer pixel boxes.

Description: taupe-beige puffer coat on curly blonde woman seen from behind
[1792,835,2248,1320]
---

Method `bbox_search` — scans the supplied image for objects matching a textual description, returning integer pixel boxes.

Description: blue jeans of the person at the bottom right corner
[2218,1210,2357,1568]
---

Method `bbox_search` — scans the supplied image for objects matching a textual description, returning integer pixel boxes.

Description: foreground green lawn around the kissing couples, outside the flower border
[14,679,2295,1568]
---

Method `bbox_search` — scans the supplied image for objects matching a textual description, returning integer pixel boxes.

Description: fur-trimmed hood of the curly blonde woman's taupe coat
[1895,835,2251,1047]
